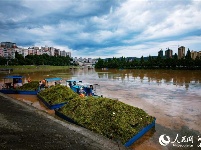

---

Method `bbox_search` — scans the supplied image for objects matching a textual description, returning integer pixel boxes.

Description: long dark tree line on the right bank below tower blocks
[95,50,201,70]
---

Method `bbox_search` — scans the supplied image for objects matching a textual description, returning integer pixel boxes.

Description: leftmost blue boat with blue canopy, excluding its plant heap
[0,75,39,95]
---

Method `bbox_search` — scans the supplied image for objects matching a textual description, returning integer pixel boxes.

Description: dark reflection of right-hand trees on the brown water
[97,70,201,90]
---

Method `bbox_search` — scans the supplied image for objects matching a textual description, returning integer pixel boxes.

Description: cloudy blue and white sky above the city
[0,0,201,58]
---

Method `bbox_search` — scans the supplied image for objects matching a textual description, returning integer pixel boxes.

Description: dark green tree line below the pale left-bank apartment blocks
[0,52,72,66]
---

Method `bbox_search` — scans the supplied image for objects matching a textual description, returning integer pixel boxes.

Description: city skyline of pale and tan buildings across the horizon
[0,42,201,59]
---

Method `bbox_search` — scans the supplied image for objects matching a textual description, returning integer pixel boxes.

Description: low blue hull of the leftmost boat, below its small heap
[0,89,39,95]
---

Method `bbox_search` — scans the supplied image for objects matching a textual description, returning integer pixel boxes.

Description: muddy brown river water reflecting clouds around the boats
[0,69,201,150]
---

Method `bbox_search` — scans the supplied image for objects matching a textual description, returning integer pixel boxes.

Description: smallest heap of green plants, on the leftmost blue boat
[16,81,39,91]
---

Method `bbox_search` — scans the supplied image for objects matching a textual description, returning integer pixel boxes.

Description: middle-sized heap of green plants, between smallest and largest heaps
[38,84,79,105]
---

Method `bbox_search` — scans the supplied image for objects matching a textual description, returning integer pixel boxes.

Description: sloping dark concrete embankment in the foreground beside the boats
[0,93,127,150]
